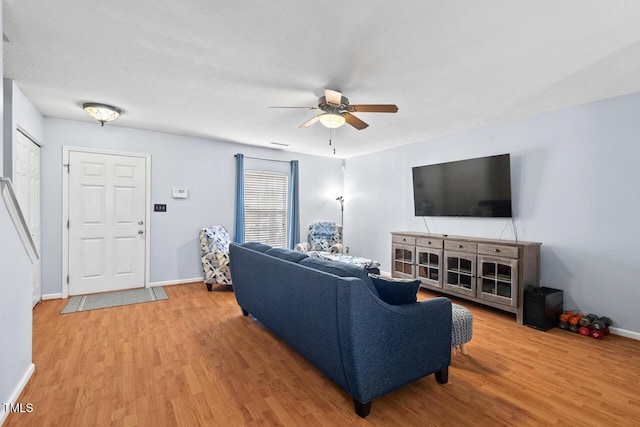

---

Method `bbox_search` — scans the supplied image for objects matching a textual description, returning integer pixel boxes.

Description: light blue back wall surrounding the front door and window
[42,118,343,295]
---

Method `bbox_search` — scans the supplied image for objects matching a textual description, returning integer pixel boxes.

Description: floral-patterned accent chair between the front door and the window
[200,225,231,291]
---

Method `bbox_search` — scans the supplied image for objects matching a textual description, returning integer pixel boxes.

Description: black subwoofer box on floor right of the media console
[524,287,563,331]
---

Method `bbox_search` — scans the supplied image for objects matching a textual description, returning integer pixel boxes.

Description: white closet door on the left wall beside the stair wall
[13,131,42,306]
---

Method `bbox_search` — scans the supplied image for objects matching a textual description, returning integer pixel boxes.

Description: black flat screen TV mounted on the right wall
[413,154,511,217]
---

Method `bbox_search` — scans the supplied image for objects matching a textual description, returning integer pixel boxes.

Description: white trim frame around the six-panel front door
[61,145,151,298]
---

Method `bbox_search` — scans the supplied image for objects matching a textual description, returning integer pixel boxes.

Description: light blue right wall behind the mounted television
[345,94,640,336]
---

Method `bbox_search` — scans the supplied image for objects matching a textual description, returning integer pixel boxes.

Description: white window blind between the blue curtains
[244,171,289,248]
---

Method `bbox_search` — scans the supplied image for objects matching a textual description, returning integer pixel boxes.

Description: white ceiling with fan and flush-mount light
[3,0,640,158]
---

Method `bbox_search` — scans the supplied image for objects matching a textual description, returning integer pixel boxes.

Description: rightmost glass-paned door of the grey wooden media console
[478,256,518,307]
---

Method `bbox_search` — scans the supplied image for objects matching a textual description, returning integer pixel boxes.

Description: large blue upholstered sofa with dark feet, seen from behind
[230,242,451,418]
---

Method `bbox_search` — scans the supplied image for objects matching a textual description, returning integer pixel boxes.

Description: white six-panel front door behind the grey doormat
[68,151,148,295]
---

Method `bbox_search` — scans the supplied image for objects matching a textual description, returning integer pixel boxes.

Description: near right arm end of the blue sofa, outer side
[338,283,451,403]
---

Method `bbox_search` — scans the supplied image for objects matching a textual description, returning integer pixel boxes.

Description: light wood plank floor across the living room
[6,283,640,426]
